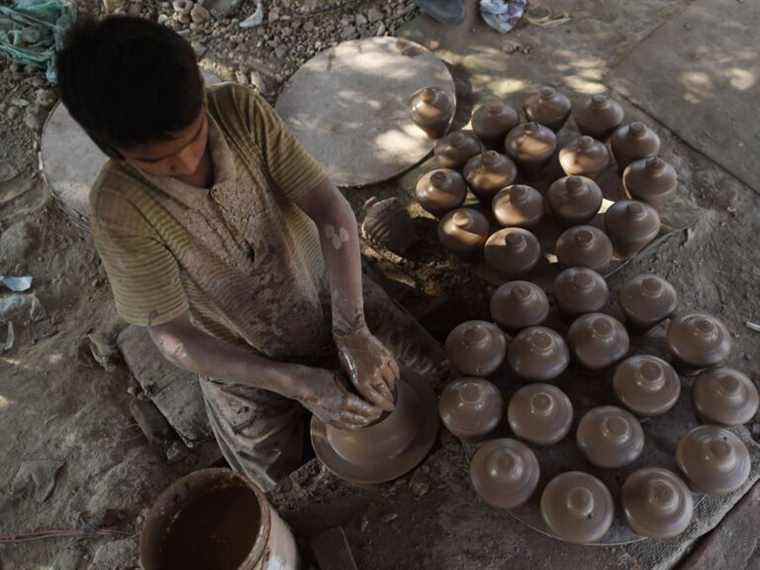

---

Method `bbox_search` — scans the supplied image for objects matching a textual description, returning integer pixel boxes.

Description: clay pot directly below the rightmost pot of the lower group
[676,426,751,495]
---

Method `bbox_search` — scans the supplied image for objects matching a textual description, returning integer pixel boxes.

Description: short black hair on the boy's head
[56,16,204,158]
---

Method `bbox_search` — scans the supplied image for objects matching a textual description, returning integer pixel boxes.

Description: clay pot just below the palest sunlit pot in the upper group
[546,176,602,226]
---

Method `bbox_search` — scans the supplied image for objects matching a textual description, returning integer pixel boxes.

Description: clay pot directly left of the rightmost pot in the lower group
[612,354,681,416]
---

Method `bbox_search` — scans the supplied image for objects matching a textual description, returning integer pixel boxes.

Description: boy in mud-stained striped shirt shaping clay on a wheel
[58,17,444,491]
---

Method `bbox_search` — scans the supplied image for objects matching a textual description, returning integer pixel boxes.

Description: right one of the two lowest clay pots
[621,467,694,538]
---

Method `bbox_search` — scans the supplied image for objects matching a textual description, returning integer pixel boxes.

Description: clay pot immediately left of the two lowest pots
[470,438,540,509]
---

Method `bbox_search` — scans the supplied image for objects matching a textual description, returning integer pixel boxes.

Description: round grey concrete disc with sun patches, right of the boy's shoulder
[276,37,456,186]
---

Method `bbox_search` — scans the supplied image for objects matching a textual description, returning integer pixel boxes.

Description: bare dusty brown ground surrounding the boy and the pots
[0,0,760,570]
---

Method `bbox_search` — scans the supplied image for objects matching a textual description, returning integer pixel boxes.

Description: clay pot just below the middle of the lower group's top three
[567,313,630,371]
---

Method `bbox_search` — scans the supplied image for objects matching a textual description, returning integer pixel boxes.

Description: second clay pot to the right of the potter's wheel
[507,383,573,445]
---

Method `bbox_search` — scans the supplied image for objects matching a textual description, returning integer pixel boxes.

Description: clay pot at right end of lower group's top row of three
[618,273,678,331]
